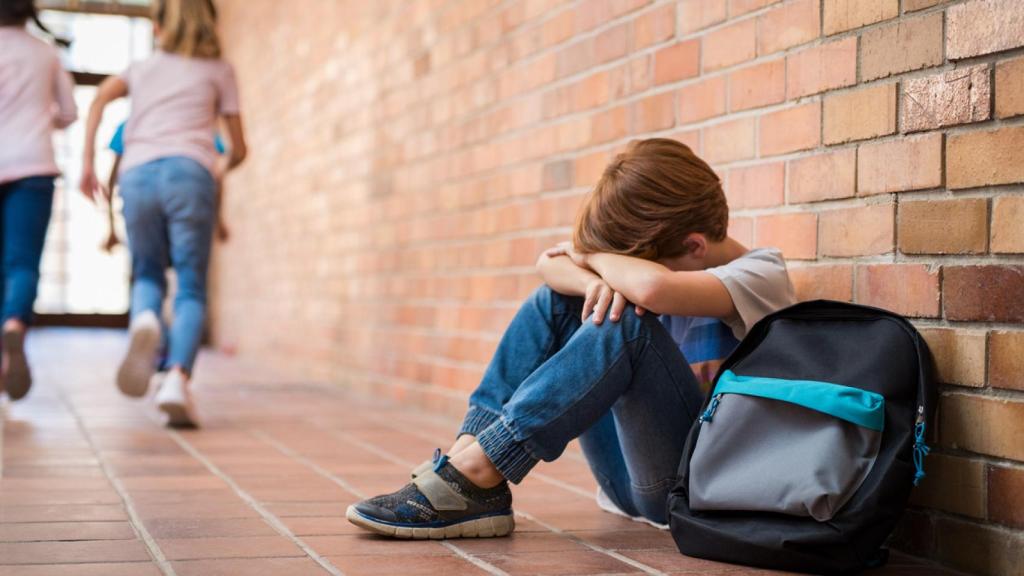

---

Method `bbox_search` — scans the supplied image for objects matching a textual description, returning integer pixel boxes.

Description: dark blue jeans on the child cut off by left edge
[0,176,53,324]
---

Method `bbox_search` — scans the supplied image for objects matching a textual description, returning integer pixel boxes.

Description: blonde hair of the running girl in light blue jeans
[153,0,220,58]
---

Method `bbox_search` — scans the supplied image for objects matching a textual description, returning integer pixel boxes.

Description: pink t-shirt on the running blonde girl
[121,51,239,171]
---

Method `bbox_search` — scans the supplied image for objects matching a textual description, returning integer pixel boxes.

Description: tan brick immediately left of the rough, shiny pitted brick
[823,84,896,145]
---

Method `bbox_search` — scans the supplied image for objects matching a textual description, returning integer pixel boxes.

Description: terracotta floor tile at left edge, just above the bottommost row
[0,540,150,564]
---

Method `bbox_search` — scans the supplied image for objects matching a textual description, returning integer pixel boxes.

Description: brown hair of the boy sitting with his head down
[572,138,729,260]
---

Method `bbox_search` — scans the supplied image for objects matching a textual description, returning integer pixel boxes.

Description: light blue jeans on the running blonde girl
[121,156,216,372]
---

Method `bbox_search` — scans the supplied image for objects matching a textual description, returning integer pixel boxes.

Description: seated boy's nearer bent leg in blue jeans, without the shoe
[477,308,702,487]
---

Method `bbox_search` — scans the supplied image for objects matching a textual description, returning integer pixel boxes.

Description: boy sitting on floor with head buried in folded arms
[346,138,794,538]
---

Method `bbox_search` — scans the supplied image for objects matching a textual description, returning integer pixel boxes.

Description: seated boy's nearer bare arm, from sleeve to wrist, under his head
[586,253,736,318]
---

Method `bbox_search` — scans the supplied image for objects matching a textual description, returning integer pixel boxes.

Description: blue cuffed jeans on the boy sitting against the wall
[460,286,703,523]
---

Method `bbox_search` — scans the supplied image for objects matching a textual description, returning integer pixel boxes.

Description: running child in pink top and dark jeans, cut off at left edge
[0,0,78,400]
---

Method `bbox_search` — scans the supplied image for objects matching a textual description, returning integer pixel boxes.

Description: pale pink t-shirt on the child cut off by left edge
[0,26,78,183]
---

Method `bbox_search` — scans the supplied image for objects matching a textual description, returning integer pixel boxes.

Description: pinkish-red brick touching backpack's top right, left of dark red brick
[856,264,939,318]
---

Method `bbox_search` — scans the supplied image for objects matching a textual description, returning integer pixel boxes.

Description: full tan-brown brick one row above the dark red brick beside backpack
[899,198,988,254]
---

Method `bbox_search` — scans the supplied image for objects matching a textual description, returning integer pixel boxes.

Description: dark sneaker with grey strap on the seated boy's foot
[345,456,515,540]
